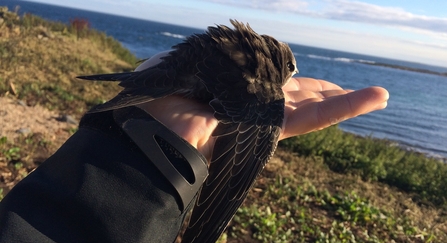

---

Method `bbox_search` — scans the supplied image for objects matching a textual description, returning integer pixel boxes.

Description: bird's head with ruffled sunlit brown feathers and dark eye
[208,20,298,87]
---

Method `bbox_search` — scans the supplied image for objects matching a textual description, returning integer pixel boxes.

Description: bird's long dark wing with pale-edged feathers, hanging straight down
[183,100,284,242]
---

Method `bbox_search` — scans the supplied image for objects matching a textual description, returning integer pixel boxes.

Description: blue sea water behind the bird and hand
[0,0,447,161]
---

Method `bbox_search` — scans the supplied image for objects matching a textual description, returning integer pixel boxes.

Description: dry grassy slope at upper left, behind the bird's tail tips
[0,5,138,115]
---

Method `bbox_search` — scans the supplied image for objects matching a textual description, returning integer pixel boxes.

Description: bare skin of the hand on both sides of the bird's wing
[140,78,388,158]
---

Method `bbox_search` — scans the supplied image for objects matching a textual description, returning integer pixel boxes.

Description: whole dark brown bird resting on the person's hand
[79,19,298,242]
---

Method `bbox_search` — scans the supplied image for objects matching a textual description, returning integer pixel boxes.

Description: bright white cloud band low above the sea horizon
[243,18,447,67]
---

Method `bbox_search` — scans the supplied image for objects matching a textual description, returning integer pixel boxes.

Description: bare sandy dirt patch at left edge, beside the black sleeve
[0,97,77,193]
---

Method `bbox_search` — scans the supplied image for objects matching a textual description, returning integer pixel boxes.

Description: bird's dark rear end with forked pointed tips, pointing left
[78,47,203,112]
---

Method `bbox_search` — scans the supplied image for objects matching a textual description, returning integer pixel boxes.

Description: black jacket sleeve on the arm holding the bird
[0,107,208,242]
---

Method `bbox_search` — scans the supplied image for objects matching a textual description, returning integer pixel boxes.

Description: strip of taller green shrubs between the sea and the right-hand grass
[281,126,447,206]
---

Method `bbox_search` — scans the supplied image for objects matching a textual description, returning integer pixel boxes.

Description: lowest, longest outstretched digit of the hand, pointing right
[280,87,389,139]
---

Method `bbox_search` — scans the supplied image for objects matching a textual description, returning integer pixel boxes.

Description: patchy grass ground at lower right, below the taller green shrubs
[226,149,447,242]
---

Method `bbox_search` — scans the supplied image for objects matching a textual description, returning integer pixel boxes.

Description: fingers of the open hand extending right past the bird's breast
[280,78,389,140]
